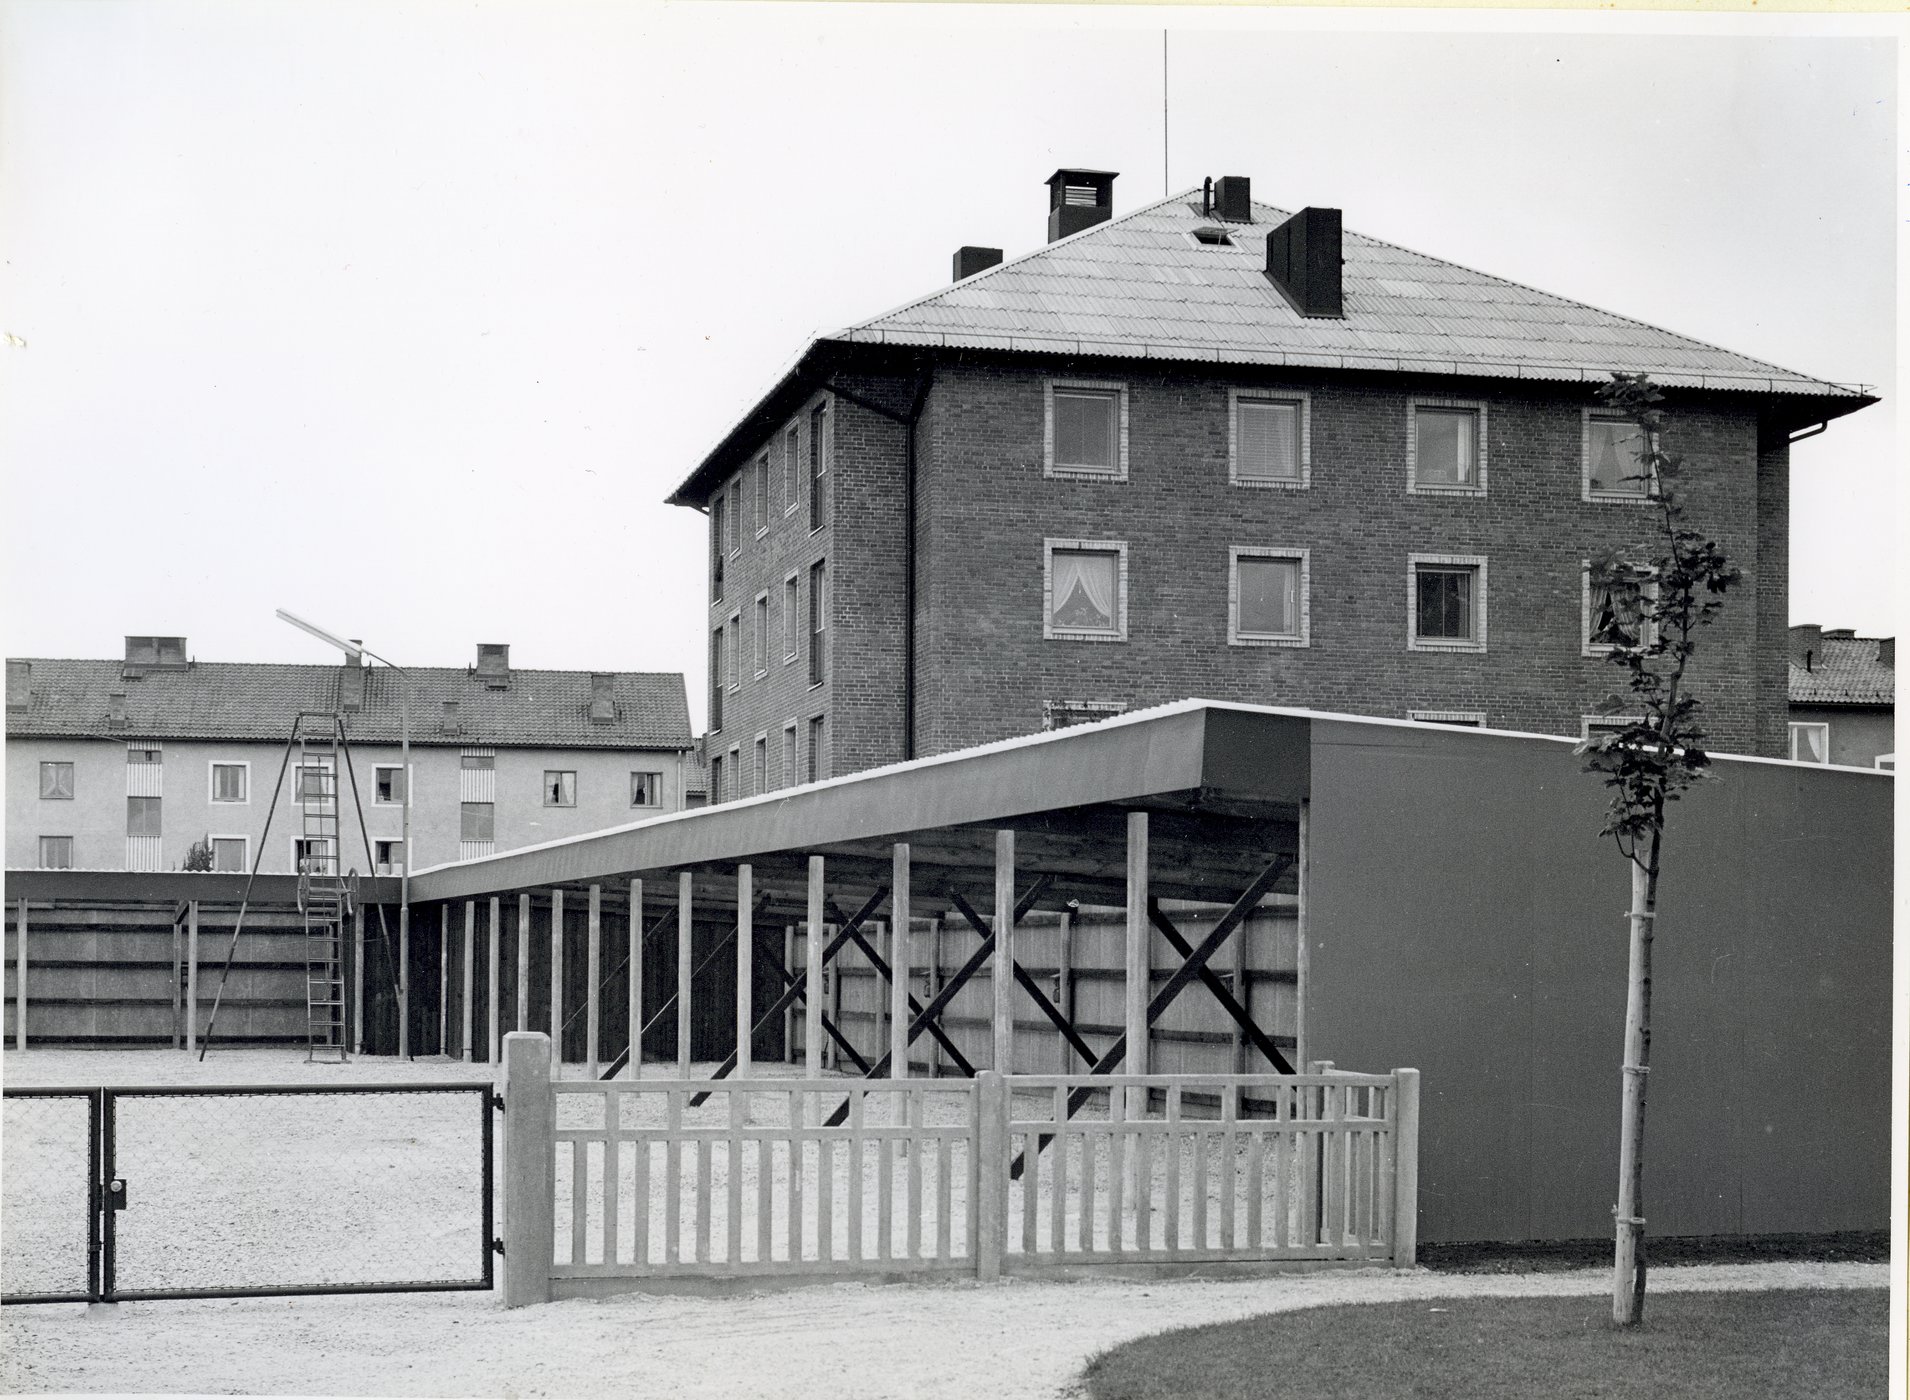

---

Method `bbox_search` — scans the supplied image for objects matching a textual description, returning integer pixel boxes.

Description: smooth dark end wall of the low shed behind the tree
[1308,720,1893,1241]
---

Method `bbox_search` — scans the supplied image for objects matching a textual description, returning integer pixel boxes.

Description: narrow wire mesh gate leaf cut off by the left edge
[0,1089,101,1303]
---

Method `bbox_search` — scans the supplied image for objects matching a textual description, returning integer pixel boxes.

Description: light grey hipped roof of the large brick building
[825,191,1868,399]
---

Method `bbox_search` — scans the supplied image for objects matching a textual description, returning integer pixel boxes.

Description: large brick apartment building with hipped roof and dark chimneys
[670,170,1874,800]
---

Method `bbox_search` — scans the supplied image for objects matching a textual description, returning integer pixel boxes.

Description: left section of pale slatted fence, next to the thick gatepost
[550,1079,978,1297]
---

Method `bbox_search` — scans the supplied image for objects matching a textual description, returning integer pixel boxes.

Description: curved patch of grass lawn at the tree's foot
[1085,1289,1889,1400]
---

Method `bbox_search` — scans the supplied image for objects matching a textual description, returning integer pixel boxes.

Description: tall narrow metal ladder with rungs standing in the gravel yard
[292,712,351,1064]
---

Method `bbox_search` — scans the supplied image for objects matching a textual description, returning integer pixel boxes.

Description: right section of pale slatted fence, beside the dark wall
[1003,1073,1400,1272]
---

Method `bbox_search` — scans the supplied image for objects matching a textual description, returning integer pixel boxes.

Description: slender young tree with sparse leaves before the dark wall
[1578,374,1738,1327]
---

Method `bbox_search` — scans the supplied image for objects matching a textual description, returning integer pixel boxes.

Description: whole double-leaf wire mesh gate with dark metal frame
[0,1083,497,1303]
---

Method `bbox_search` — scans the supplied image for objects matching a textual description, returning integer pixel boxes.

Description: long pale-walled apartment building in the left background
[6,638,691,873]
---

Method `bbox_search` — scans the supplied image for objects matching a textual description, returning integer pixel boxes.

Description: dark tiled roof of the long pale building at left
[6,657,691,749]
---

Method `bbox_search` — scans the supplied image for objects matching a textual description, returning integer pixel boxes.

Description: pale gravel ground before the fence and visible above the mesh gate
[0,1050,1889,1400]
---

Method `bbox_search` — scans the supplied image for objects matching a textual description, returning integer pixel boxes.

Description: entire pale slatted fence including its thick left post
[502,1033,1419,1306]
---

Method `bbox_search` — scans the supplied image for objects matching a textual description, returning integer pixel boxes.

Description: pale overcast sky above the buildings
[0,0,1899,714]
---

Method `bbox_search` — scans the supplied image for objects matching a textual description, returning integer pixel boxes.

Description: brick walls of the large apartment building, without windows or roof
[711,355,1788,796]
